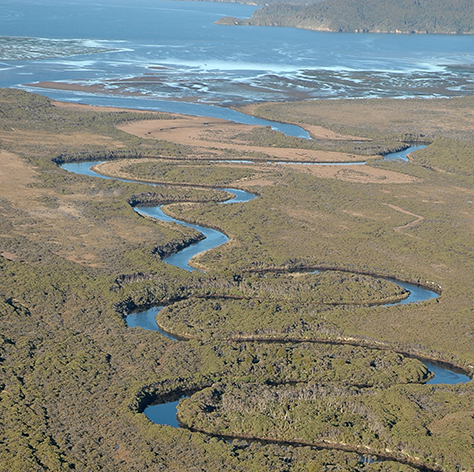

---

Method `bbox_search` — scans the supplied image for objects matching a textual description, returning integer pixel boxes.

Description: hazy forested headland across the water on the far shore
[218,0,474,34]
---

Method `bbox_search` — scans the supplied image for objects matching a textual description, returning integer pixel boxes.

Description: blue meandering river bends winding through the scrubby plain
[62,152,471,427]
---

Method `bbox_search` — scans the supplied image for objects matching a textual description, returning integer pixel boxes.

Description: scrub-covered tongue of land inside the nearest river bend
[178,383,474,471]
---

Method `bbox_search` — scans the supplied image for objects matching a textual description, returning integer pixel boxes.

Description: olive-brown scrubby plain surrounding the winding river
[0,90,474,471]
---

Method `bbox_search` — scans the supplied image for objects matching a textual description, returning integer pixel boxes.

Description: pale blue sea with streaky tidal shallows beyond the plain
[0,0,474,111]
